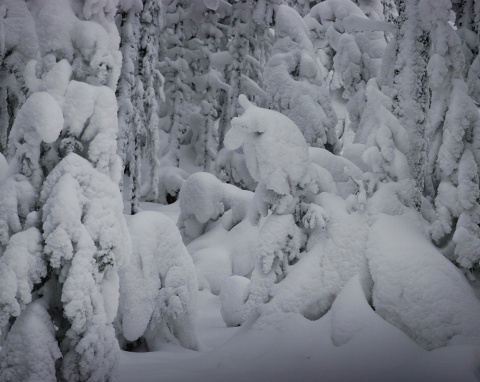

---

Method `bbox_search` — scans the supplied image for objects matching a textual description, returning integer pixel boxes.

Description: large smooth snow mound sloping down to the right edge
[367,214,480,349]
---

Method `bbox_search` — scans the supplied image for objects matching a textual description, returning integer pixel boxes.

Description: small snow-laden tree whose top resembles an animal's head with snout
[225,95,334,320]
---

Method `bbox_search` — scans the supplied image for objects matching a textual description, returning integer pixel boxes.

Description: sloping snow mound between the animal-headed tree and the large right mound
[253,193,370,327]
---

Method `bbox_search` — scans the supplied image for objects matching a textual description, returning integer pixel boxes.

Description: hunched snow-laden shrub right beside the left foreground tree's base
[117,212,198,351]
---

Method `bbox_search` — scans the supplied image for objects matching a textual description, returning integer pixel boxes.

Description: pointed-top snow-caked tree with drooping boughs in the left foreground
[40,153,130,381]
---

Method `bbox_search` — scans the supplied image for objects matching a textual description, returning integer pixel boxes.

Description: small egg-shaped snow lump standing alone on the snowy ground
[220,276,250,326]
